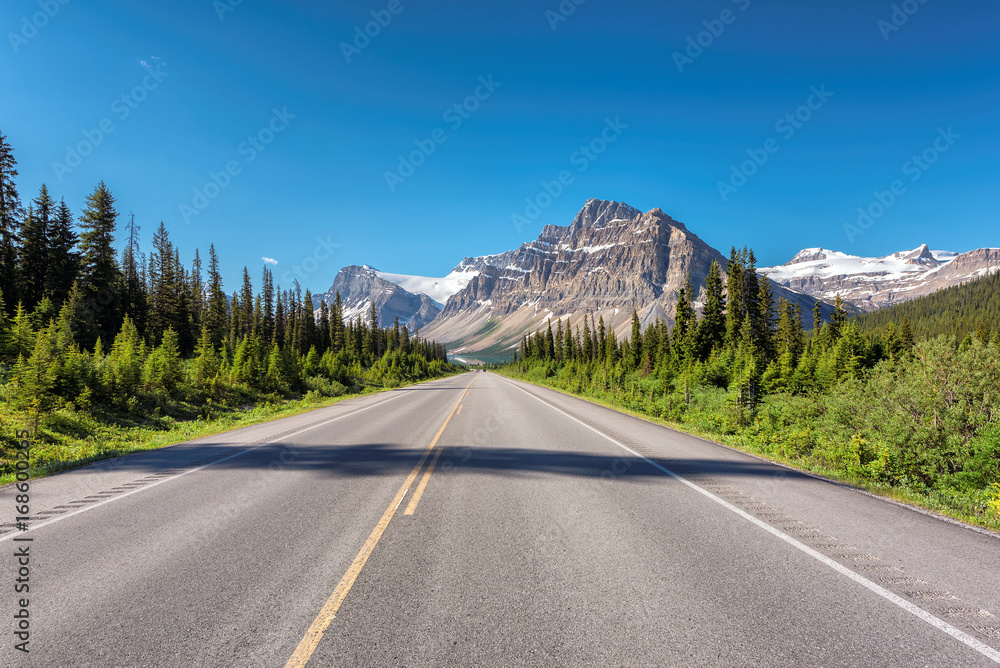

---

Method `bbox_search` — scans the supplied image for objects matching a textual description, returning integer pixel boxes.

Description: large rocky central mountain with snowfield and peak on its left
[322,200,832,353]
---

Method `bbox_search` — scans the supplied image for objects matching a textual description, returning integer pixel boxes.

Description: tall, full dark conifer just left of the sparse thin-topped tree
[80,181,121,341]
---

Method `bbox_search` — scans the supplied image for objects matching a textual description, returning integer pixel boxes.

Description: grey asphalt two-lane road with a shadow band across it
[0,373,1000,667]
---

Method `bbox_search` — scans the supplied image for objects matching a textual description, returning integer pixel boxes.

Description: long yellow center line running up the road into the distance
[285,376,477,668]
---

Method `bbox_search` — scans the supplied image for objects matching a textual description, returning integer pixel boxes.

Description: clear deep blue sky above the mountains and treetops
[0,0,1000,290]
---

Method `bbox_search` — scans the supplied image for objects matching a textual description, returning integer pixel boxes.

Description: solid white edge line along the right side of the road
[497,376,1000,663]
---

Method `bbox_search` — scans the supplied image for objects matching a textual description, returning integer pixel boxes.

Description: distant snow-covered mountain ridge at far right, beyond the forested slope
[760,244,1000,311]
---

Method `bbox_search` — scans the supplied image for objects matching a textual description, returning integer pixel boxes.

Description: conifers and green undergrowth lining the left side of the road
[0,134,458,482]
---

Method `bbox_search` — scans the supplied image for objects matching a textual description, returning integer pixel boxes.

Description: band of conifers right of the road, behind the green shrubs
[515,247,914,409]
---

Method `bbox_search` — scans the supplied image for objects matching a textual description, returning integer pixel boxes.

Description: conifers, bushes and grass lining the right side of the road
[497,249,1000,529]
